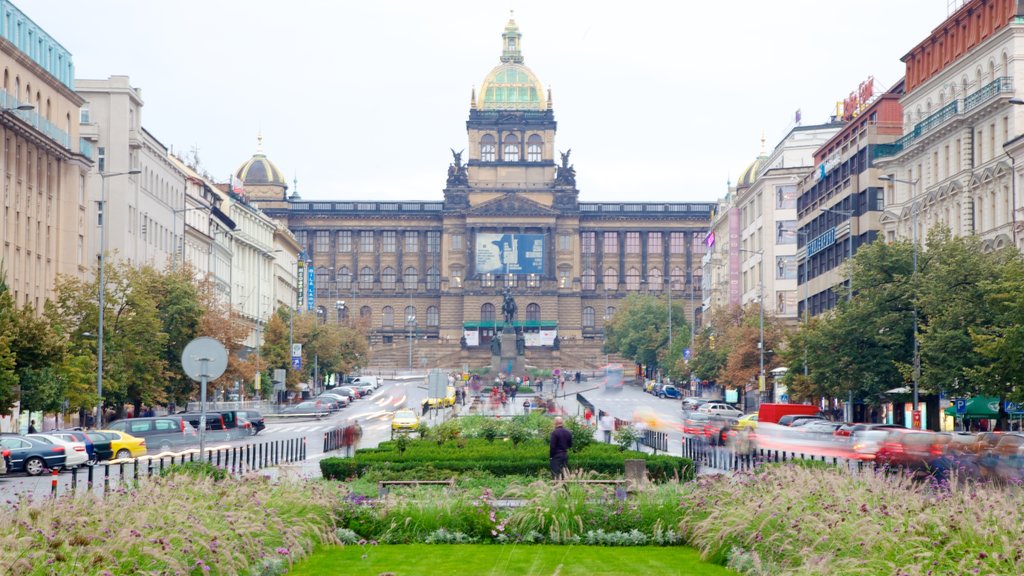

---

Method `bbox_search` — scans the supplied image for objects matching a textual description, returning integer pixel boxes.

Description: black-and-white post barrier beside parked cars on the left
[58,438,306,496]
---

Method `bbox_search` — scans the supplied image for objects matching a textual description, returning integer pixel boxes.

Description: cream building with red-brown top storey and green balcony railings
[876,0,1024,249]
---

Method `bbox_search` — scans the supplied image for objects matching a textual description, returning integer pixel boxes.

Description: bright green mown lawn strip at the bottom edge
[289,544,736,576]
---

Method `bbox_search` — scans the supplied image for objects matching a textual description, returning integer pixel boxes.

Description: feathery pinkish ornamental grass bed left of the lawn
[0,467,345,576]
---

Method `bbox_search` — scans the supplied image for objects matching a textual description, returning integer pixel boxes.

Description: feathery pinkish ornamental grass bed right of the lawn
[679,465,1024,576]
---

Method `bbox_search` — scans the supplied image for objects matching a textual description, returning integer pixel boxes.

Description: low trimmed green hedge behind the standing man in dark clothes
[321,440,693,482]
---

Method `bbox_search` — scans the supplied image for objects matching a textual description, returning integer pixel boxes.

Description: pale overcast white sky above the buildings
[24,0,948,201]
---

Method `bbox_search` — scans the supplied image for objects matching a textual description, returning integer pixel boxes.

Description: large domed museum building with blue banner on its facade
[246,19,714,368]
